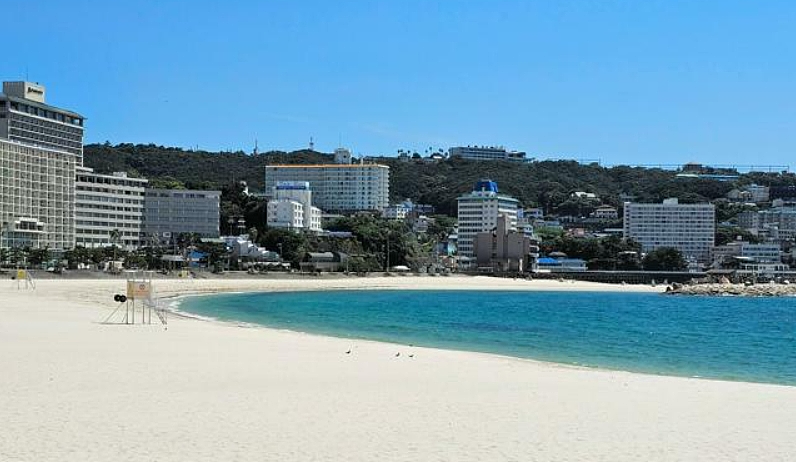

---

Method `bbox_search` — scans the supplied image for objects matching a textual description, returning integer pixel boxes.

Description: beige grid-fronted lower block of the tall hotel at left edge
[0,137,78,251]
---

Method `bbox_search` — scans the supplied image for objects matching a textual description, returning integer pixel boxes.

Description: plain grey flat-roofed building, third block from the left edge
[144,189,221,243]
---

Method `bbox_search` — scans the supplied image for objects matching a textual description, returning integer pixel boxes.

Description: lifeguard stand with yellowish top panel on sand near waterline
[103,271,168,324]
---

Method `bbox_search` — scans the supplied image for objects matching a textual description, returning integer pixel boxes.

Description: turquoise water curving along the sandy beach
[180,291,796,385]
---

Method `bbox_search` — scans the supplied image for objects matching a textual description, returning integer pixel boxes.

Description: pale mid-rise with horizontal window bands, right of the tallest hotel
[75,167,147,250]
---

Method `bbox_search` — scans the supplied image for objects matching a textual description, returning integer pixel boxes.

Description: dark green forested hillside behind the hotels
[85,143,796,214]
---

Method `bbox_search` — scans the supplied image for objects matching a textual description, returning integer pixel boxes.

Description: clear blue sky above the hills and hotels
[0,0,796,167]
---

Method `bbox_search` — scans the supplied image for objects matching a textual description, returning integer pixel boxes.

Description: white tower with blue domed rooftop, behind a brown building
[457,180,519,259]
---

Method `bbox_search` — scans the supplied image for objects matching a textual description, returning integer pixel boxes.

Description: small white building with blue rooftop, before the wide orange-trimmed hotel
[267,181,322,232]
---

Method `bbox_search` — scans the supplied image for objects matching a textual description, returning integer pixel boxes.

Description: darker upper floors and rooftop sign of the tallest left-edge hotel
[0,82,85,165]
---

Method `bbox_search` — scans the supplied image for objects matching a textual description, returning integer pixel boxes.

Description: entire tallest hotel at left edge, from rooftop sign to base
[0,82,84,251]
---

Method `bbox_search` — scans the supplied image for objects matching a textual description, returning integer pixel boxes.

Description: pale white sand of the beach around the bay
[0,277,796,462]
